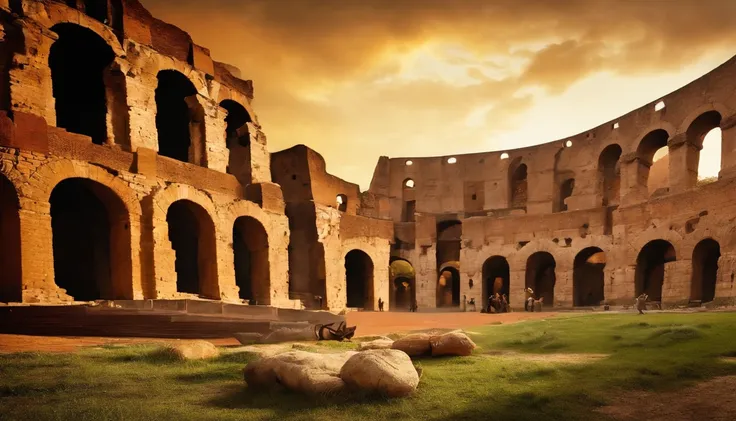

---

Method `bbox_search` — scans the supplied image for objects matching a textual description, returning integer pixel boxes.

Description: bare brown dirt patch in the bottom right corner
[599,376,736,421]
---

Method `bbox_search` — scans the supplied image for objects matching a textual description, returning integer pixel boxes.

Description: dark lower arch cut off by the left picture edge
[0,175,23,303]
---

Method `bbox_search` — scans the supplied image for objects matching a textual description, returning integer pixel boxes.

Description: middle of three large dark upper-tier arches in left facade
[156,70,205,165]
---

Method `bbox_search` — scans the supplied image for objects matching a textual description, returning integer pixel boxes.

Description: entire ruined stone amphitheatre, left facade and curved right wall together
[0,0,736,311]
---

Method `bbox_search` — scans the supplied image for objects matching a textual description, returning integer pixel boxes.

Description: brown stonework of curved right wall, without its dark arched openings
[369,51,736,308]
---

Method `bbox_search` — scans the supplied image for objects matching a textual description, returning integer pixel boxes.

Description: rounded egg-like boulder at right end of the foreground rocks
[340,349,419,397]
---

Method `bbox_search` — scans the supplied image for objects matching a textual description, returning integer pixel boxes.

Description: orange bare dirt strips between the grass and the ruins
[0,312,555,353]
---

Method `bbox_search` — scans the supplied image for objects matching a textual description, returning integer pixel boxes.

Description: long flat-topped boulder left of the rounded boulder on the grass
[243,351,356,395]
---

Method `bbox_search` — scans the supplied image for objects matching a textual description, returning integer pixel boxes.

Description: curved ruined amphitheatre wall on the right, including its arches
[370,58,736,308]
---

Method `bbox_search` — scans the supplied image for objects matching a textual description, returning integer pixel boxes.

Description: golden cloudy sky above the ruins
[142,0,736,189]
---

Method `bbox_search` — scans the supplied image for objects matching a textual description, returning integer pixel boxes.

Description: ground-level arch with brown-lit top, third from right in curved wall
[572,247,606,307]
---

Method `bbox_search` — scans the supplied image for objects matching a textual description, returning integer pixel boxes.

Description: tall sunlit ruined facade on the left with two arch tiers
[0,0,393,310]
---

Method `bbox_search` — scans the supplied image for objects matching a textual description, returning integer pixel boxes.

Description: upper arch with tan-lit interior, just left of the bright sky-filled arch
[637,129,670,196]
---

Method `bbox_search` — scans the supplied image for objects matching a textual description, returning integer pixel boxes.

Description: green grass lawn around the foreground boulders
[0,313,736,421]
